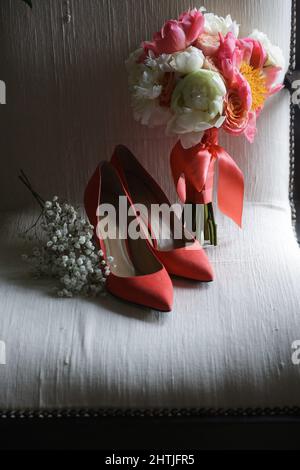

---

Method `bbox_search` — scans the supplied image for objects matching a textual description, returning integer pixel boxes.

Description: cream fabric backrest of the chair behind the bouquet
[0,0,291,209]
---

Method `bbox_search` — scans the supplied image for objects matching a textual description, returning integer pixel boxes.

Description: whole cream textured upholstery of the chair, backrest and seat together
[0,0,300,407]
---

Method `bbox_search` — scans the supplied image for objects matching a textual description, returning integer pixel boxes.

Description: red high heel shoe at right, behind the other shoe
[111,145,213,282]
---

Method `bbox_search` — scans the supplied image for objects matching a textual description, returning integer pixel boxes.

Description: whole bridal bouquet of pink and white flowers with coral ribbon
[126,8,284,244]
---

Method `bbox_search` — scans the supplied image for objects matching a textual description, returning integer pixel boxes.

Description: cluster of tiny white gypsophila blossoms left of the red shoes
[23,196,113,297]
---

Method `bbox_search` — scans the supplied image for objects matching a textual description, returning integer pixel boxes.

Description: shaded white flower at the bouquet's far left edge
[126,49,171,127]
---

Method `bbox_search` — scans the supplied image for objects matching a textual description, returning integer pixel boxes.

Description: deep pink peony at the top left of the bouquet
[142,8,204,56]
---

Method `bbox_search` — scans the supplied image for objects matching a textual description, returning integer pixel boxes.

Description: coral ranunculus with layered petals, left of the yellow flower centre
[223,74,252,135]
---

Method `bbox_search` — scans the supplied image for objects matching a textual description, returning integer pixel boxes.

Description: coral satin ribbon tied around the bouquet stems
[171,129,244,227]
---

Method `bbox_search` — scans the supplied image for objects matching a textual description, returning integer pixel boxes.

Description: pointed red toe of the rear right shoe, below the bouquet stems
[157,242,214,282]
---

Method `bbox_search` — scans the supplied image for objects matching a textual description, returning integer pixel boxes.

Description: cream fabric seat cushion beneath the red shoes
[0,204,300,408]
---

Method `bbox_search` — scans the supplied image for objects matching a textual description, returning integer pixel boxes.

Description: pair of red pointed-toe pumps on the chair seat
[84,145,213,311]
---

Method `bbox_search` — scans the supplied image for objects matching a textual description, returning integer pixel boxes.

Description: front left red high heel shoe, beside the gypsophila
[84,162,173,311]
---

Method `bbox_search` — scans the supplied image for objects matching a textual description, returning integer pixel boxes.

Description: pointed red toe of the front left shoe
[107,268,173,312]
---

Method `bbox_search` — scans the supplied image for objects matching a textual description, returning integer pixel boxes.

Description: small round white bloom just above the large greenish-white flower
[170,46,205,75]
